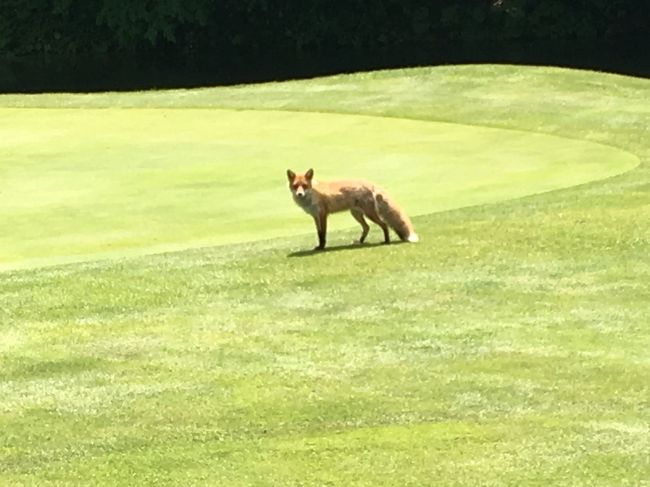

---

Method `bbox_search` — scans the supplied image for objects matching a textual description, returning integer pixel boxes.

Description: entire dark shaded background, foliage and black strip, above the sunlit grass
[0,0,650,90]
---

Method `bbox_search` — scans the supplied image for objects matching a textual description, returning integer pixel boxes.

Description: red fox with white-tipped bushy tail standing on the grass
[287,169,418,250]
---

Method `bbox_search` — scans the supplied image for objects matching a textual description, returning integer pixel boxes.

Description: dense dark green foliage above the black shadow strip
[0,0,650,62]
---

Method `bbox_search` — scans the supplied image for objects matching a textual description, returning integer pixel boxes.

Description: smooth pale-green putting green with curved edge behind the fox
[0,108,639,269]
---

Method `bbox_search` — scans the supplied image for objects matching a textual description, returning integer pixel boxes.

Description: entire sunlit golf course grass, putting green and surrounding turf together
[0,66,650,486]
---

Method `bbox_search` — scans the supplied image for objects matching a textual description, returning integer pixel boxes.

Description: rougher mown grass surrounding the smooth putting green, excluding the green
[0,66,650,486]
